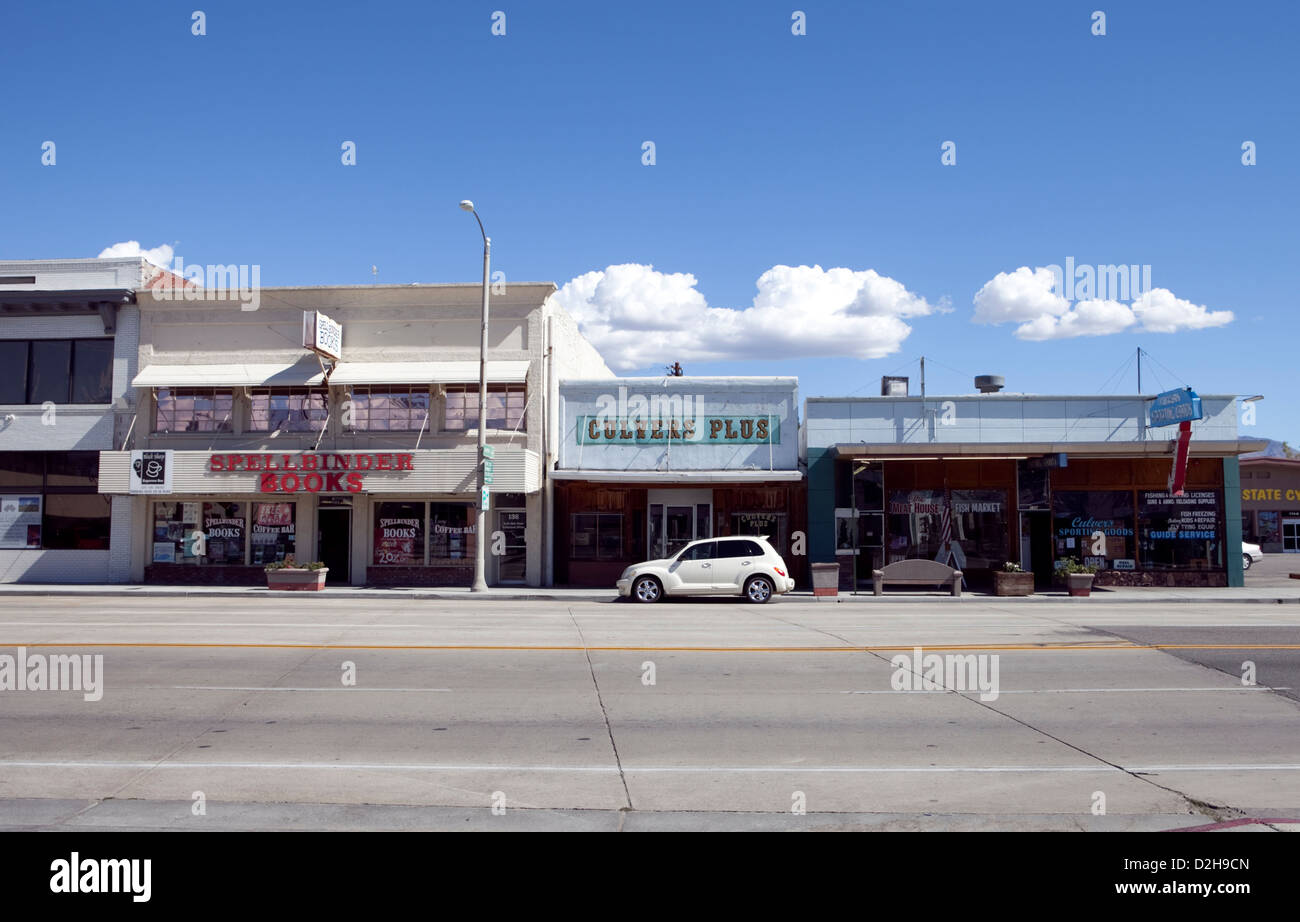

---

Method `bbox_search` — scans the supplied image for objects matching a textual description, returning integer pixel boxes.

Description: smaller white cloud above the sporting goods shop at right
[971,265,1232,341]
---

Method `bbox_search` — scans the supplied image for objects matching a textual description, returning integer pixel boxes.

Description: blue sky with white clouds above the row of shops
[0,0,1300,442]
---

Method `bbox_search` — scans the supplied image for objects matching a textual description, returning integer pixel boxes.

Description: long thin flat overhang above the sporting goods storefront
[832,440,1266,460]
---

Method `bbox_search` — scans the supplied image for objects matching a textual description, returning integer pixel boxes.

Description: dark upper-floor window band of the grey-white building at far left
[0,339,113,404]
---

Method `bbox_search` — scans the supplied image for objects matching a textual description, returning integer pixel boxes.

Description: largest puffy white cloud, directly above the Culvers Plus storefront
[555,263,948,371]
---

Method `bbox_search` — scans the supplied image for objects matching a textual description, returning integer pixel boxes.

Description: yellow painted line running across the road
[0,641,1300,653]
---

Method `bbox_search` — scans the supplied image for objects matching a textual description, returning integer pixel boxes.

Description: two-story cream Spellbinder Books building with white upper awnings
[99,282,611,585]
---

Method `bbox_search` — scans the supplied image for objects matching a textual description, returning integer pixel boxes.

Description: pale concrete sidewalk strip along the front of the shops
[0,581,1300,606]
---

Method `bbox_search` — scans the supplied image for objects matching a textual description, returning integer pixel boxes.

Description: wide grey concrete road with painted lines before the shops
[0,597,1300,830]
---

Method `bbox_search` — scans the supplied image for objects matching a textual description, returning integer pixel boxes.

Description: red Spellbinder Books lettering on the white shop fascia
[208,451,415,493]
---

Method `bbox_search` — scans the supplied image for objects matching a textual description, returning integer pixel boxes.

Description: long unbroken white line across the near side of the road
[0,761,1300,775]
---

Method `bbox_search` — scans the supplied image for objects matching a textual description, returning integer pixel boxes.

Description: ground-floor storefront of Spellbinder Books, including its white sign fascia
[100,447,537,586]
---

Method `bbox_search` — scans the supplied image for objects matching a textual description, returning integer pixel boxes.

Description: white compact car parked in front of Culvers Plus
[616,536,794,605]
